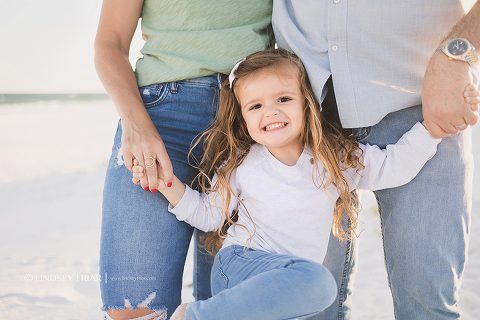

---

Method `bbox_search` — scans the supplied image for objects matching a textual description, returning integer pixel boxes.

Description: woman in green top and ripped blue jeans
[95,0,272,319]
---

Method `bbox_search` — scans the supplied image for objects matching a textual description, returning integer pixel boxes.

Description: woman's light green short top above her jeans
[135,0,273,87]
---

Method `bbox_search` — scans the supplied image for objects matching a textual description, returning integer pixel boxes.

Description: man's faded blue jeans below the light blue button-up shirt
[311,106,473,320]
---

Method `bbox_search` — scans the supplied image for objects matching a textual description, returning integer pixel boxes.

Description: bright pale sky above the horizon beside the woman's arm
[0,0,142,94]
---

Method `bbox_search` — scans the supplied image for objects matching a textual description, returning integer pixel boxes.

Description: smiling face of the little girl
[237,65,305,165]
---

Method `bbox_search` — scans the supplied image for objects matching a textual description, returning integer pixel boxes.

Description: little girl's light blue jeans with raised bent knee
[185,245,337,320]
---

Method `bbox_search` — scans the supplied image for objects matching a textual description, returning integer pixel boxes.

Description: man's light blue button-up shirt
[273,0,478,128]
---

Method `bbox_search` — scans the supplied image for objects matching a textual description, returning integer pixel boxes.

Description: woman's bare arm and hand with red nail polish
[95,0,173,190]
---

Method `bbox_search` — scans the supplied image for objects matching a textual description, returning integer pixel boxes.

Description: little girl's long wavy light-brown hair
[189,49,364,254]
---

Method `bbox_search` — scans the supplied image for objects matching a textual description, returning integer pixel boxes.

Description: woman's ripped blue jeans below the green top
[100,74,221,314]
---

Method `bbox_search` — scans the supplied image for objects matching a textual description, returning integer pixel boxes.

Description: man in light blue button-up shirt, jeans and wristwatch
[273,0,480,320]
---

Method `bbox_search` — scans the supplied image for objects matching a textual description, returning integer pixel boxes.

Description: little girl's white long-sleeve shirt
[169,123,440,263]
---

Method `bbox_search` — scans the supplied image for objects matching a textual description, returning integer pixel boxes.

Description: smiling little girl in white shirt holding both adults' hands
[133,49,480,320]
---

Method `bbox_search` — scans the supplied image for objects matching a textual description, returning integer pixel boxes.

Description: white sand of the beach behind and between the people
[0,101,480,320]
